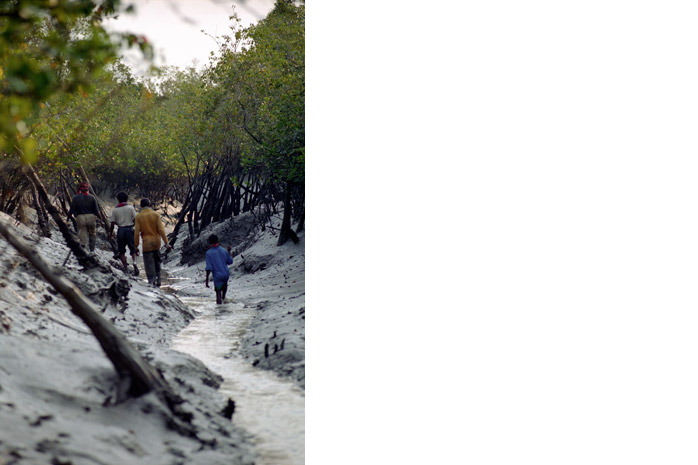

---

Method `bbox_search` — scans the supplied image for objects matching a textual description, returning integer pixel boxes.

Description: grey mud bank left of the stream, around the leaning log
[0,214,256,464]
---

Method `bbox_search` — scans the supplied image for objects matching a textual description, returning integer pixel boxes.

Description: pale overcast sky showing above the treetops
[106,0,274,74]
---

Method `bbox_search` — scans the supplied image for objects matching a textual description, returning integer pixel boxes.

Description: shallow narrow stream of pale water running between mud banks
[172,297,305,465]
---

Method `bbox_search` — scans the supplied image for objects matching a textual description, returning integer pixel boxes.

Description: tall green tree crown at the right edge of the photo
[209,1,305,183]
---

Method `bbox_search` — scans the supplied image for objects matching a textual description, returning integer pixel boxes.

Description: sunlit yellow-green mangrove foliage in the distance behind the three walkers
[33,62,202,198]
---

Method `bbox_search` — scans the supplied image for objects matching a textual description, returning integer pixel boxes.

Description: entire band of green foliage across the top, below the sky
[0,0,305,218]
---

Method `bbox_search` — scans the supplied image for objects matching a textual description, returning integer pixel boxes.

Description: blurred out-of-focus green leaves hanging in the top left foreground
[0,0,151,162]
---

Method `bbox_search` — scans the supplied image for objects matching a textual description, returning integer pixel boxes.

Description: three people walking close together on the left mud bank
[68,182,172,287]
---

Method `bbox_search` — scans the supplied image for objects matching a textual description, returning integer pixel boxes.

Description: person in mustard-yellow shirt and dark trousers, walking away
[134,199,172,287]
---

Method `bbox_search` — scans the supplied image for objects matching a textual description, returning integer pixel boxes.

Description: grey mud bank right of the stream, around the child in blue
[166,214,305,389]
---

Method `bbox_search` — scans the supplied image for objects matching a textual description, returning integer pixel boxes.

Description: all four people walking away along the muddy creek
[68,182,233,305]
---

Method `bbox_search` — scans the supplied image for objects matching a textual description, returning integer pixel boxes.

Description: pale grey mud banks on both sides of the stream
[0,207,305,464]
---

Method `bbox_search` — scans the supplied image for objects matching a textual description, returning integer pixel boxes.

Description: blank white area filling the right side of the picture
[306,0,698,465]
